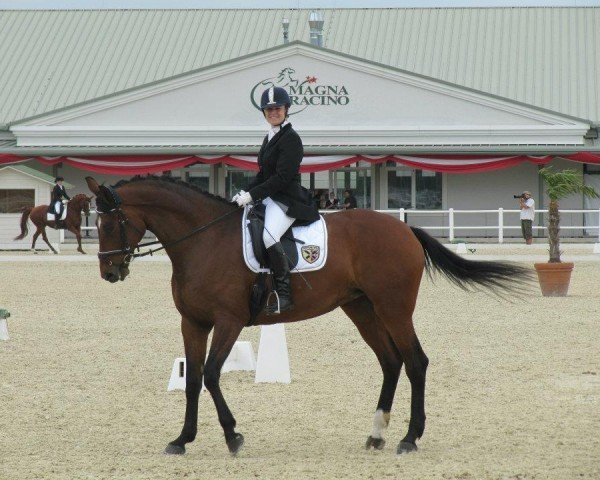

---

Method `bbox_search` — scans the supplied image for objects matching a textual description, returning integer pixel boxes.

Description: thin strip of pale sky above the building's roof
[0,0,600,10]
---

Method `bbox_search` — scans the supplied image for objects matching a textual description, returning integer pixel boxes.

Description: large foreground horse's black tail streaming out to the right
[410,227,533,295]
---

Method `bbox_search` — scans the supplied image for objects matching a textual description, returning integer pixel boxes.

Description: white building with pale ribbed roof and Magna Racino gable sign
[0,8,600,236]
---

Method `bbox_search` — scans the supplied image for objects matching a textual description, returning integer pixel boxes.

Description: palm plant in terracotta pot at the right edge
[535,166,600,297]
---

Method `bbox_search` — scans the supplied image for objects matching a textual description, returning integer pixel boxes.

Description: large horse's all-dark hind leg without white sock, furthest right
[374,300,429,453]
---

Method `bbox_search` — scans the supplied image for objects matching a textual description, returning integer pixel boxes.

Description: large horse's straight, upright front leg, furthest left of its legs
[165,317,211,455]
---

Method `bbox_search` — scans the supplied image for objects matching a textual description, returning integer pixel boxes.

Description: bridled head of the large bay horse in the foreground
[85,177,146,283]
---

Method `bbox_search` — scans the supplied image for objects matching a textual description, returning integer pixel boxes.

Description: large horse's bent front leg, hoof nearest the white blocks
[204,315,244,455]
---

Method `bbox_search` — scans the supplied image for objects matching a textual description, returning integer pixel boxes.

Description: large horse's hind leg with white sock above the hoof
[342,297,402,450]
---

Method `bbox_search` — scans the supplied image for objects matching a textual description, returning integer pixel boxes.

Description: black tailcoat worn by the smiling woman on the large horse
[248,123,319,223]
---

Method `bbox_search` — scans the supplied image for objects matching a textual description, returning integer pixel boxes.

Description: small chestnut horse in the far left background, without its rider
[15,193,94,254]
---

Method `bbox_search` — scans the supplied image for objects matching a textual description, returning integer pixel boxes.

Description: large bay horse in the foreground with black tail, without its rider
[86,176,530,455]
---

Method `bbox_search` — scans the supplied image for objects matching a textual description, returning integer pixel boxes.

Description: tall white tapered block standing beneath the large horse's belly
[254,323,292,383]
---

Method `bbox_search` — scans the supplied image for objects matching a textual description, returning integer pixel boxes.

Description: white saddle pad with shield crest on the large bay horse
[242,206,327,273]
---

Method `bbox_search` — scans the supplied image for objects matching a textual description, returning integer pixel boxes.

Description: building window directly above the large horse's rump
[386,162,442,210]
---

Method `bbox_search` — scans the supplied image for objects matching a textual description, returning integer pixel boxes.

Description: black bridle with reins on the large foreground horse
[96,186,238,268]
